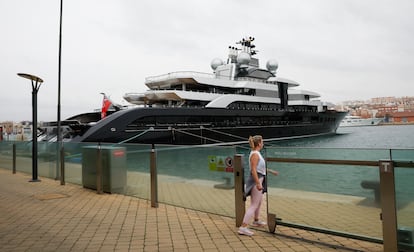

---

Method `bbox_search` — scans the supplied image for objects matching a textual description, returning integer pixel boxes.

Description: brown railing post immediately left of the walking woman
[234,154,246,227]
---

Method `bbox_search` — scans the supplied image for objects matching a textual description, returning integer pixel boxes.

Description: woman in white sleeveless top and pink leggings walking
[238,135,279,236]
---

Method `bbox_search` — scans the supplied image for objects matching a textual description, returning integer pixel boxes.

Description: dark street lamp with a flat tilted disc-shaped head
[17,73,43,182]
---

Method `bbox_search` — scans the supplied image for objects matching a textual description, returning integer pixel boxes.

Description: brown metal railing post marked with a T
[379,160,398,251]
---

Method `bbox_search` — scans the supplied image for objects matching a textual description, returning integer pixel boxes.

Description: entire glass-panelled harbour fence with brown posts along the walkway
[0,141,414,251]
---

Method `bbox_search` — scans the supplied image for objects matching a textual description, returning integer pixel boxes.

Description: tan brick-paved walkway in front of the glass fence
[0,169,383,251]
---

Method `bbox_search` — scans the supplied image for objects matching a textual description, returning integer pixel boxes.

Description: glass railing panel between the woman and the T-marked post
[266,148,387,239]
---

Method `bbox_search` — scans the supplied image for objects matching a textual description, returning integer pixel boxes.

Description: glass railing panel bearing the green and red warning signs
[157,146,235,217]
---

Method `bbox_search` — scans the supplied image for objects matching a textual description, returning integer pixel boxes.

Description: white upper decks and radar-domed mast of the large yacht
[124,37,323,111]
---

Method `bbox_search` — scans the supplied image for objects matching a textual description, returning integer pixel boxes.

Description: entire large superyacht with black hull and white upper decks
[65,37,346,145]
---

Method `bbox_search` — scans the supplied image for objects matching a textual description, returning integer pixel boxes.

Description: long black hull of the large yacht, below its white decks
[72,108,346,145]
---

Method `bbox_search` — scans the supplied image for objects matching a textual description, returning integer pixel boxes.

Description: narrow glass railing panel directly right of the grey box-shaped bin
[123,144,151,200]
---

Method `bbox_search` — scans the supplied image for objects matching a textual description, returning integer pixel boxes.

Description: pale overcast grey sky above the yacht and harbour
[0,0,414,122]
